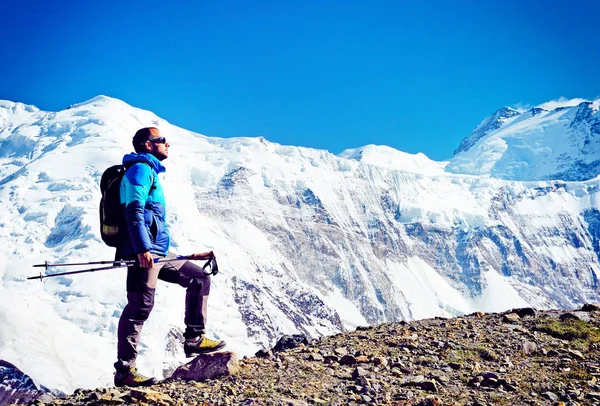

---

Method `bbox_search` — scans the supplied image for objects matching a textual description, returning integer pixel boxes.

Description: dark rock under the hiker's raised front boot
[172,351,239,381]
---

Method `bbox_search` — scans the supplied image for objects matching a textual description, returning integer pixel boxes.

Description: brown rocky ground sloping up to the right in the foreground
[27,305,600,406]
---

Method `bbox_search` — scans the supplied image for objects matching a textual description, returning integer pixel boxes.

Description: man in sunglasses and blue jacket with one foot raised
[114,127,225,386]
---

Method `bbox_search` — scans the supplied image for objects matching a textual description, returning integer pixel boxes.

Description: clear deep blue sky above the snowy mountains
[0,0,600,160]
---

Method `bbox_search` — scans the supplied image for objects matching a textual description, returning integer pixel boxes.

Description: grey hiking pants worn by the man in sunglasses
[115,253,210,371]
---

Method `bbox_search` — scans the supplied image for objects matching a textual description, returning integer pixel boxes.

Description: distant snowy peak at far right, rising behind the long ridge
[446,99,600,180]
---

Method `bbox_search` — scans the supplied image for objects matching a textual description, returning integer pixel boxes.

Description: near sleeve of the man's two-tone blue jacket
[123,163,154,254]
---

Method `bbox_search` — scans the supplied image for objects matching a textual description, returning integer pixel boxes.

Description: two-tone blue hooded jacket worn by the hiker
[118,152,171,258]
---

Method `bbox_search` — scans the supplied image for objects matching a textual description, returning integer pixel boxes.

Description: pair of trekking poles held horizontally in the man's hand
[27,251,219,282]
